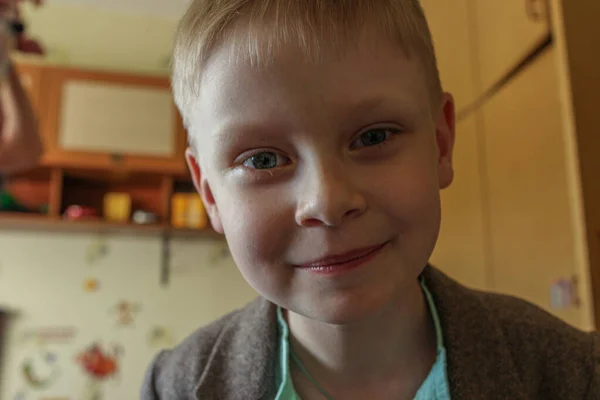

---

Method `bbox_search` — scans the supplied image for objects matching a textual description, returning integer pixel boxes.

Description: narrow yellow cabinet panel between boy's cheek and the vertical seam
[431,116,489,289]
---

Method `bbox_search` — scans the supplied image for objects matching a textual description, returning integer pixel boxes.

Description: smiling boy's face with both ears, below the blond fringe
[188,28,454,323]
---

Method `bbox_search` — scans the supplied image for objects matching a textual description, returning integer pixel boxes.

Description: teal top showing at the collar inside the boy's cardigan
[275,279,450,400]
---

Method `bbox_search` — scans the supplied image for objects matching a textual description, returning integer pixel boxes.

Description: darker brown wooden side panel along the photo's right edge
[553,0,600,330]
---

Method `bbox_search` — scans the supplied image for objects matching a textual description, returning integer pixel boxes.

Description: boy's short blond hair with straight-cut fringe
[172,0,442,134]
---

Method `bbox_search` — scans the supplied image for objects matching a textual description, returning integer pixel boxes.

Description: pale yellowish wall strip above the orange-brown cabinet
[24,0,177,73]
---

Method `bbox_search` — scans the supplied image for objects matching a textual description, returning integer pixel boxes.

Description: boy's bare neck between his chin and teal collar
[287,281,437,398]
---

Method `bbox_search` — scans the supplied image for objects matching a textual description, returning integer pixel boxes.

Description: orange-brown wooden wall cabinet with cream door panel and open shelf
[0,63,214,236]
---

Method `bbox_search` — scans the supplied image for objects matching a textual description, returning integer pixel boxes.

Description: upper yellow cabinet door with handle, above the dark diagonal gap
[469,0,550,92]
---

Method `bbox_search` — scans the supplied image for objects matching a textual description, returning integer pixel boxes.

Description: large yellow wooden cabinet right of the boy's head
[422,0,600,330]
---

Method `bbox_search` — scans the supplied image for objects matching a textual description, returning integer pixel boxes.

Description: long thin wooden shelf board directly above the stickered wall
[0,212,223,239]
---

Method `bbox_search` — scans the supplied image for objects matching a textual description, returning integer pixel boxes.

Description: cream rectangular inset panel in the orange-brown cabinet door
[58,81,175,157]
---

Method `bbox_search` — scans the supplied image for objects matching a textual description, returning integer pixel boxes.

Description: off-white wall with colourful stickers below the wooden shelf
[0,231,255,400]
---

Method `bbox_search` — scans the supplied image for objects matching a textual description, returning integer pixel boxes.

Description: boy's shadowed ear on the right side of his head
[436,93,456,189]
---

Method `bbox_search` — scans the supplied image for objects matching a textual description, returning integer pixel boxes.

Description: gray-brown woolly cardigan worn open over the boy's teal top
[141,267,600,400]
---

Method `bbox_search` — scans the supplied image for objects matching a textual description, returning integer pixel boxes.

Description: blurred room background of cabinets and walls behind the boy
[0,0,600,400]
